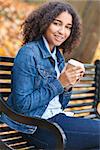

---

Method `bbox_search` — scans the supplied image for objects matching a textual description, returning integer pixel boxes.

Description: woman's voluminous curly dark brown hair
[23,1,82,52]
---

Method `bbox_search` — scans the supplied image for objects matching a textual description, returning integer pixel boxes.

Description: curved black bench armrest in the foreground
[0,97,66,150]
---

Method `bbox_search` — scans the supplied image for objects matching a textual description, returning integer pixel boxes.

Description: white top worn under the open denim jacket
[42,37,72,119]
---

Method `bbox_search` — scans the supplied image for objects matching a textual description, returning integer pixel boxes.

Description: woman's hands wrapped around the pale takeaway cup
[59,65,85,88]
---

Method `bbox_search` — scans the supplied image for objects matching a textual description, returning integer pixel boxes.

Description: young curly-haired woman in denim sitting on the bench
[1,1,100,150]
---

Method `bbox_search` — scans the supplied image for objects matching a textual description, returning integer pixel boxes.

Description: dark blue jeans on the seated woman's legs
[22,114,100,150]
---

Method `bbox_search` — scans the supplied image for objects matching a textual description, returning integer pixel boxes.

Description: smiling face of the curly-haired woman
[44,11,72,51]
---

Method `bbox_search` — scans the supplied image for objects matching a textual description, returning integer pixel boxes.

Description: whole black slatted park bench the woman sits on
[0,57,100,150]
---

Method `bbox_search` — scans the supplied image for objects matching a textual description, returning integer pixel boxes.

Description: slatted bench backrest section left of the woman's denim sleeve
[0,57,14,99]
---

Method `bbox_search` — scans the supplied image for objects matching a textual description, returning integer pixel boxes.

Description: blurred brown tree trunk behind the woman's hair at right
[65,0,100,63]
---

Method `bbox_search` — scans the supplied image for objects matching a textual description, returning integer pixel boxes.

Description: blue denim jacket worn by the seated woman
[0,38,71,133]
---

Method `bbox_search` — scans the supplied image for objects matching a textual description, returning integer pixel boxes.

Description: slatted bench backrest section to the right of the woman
[67,60,100,118]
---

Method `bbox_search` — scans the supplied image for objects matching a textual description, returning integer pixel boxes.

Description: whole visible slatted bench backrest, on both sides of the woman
[0,57,100,118]
